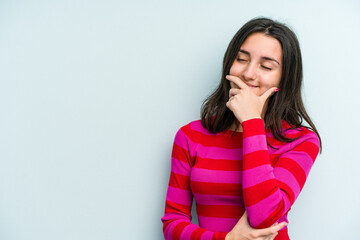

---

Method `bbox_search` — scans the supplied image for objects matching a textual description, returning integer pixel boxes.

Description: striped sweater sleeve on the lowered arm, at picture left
[161,124,227,240]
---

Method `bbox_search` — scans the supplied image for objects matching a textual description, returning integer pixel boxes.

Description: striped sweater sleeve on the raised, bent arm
[242,119,319,228]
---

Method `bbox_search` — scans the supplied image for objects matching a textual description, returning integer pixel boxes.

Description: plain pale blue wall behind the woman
[0,0,360,240]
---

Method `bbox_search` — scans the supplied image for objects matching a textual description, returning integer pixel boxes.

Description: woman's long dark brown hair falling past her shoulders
[201,18,322,151]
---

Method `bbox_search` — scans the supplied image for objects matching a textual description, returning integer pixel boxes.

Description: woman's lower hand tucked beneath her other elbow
[225,211,287,240]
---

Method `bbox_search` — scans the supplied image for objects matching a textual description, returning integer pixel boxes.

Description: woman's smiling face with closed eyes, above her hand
[230,33,282,96]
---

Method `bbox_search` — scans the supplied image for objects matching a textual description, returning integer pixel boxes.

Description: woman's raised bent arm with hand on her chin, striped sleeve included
[226,75,319,228]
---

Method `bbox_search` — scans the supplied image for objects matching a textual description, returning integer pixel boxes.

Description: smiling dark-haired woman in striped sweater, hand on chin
[162,18,321,240]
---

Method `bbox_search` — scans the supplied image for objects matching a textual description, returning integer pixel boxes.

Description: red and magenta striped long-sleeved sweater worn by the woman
[161,119,319,240]
